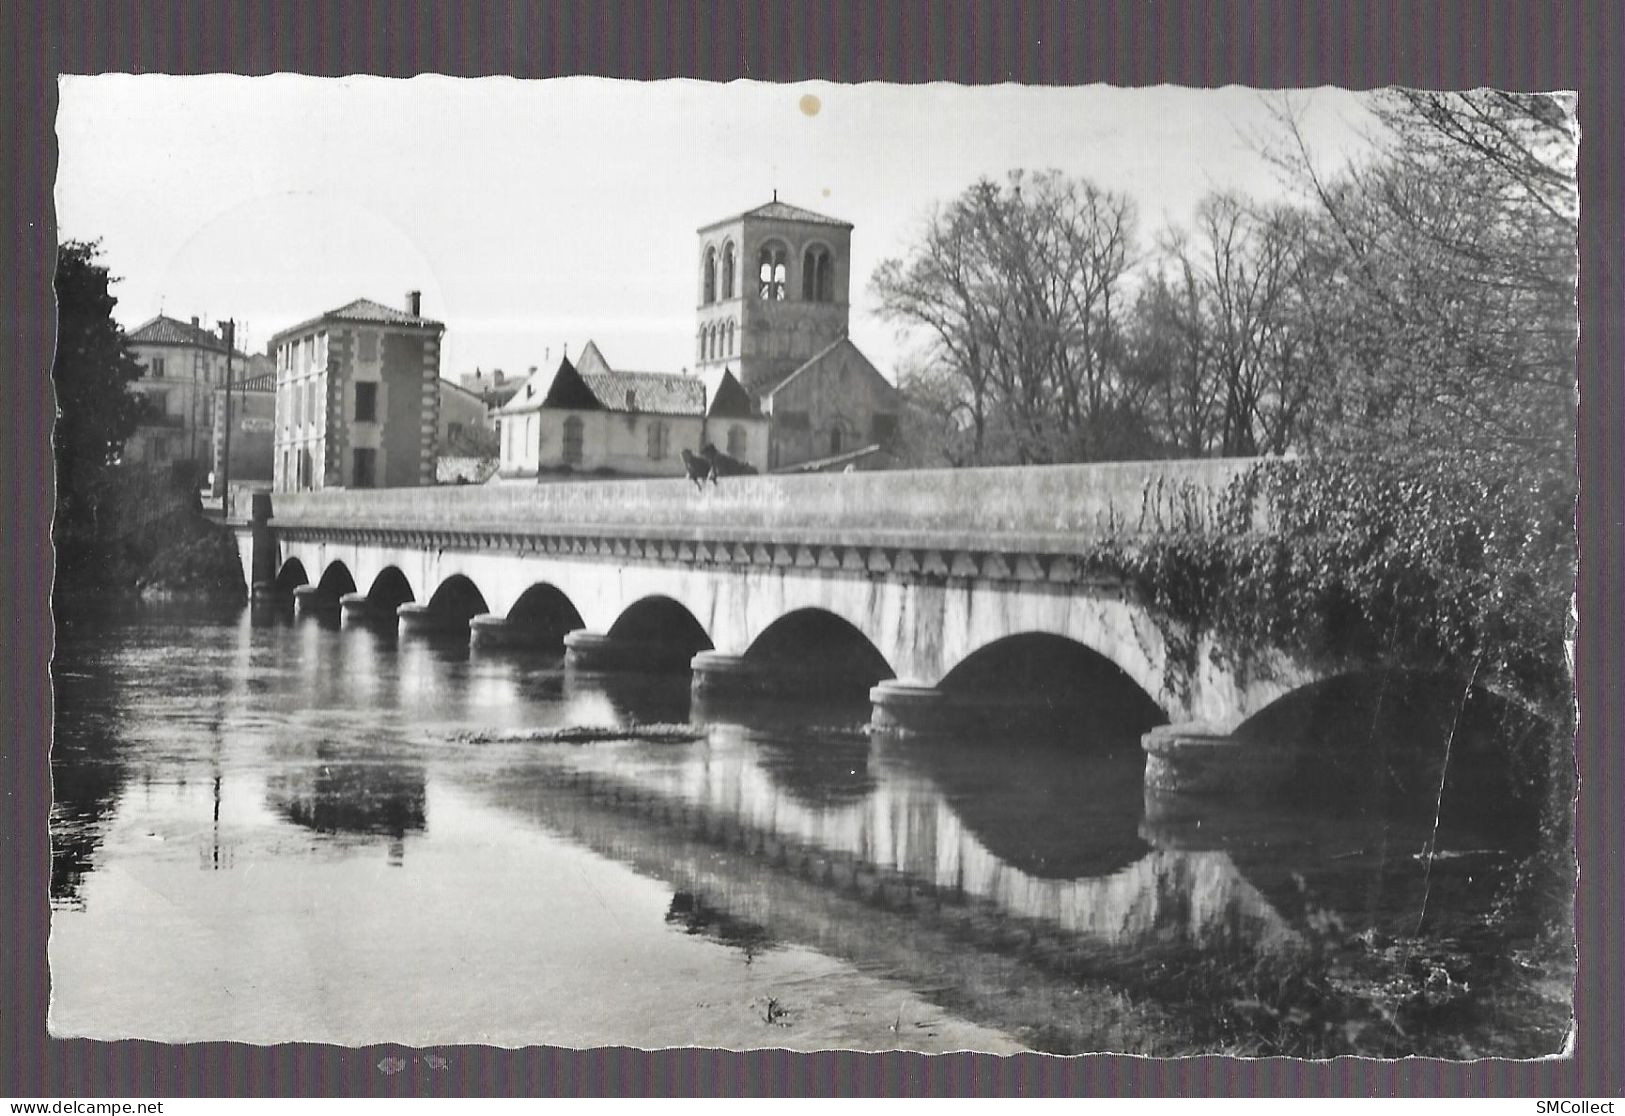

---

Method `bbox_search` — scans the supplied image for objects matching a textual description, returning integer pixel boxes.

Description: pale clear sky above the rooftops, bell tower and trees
[55,75,1370,377]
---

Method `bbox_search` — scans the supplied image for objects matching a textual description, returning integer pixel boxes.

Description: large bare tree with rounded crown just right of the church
[873,171,1136,465]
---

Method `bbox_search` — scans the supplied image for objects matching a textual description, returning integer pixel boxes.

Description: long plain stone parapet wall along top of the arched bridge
[273,458,1258,554]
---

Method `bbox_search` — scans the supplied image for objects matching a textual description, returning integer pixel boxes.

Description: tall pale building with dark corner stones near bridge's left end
[271,291,445,492]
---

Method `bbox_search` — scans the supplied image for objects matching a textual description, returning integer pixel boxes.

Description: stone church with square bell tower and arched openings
[696,193,902,469]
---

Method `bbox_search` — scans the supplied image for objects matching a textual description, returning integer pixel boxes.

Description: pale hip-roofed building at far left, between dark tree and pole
[124,314,252,473]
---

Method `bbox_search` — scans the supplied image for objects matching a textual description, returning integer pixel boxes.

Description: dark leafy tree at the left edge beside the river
[50,240,143,572]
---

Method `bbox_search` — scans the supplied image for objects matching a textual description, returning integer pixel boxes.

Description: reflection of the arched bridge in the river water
[461,725,1332,1049]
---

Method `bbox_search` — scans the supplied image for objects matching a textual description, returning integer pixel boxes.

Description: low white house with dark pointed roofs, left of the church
[496,341,767,478]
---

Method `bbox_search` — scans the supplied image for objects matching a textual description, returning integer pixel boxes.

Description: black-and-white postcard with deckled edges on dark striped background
[42,73,1580,1061]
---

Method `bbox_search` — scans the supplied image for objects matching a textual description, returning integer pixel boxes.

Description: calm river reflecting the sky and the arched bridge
[50,604,1567,1056]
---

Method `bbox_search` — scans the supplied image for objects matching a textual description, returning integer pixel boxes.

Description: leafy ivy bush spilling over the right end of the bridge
[1086,456,1575,723]
